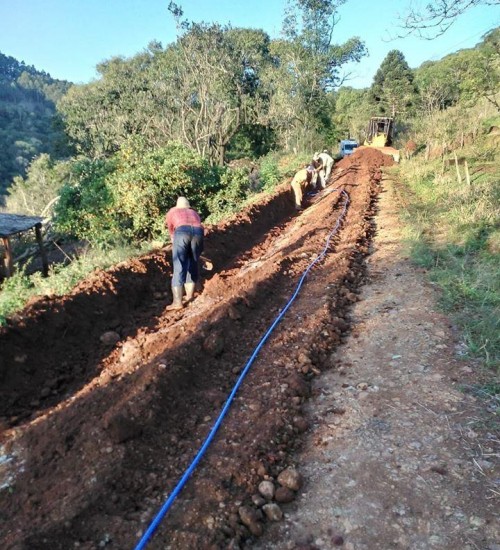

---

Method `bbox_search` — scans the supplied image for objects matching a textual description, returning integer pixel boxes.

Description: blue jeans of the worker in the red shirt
[172,225,203,286]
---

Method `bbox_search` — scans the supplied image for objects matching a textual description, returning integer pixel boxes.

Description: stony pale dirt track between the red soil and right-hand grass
[254,175,500,550]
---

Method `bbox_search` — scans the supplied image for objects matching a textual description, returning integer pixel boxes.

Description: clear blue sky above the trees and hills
[0,0,500,88]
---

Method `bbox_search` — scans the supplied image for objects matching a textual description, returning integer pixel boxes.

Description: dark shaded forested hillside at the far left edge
[0,52,70,196]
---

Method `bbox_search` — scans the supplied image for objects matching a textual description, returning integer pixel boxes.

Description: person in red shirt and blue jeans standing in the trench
[165,197,204,310]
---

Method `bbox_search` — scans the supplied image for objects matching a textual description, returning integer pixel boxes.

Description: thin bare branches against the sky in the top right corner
[400,0,500,40]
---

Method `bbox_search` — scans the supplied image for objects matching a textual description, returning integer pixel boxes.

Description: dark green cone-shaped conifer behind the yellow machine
[371,50,417,117]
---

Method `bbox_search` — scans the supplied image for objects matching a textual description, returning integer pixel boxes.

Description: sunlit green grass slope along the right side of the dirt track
[399,140,500,369]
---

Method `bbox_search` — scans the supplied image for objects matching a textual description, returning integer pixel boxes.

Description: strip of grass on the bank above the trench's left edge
[0,247,146,325]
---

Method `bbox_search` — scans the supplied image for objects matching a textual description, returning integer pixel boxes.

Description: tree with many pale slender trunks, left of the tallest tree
[159,23,269,165]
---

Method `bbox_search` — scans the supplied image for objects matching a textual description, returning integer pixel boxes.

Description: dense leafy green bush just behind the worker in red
[55,138,221,246]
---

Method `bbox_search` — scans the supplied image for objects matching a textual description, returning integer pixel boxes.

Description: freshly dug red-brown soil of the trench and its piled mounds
[0,150,391,550]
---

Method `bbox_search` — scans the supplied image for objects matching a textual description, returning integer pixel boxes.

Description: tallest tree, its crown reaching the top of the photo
[264,0,366,150]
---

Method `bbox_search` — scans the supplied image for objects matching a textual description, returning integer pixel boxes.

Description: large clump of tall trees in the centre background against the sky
[59,4,366,166]
